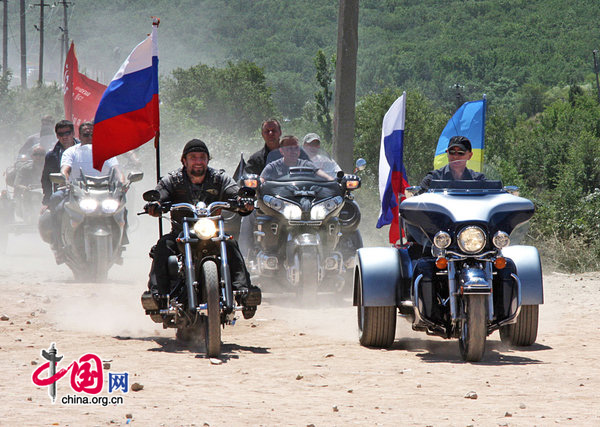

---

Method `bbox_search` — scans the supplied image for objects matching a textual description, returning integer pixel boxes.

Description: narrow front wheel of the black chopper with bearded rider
[202,261,221,357]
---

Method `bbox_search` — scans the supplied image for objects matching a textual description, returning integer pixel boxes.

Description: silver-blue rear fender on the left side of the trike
[353,248,412,307]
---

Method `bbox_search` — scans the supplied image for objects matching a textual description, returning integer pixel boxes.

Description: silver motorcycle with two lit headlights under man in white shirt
[46,170,144,282]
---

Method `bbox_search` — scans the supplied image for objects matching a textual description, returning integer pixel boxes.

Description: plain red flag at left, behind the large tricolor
[63,42,106,136]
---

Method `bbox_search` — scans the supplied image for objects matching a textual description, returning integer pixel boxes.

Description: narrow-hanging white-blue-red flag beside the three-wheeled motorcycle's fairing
[377,92,408,244]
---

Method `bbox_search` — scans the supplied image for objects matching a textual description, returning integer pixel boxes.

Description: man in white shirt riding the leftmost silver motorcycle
[60,122,120,182]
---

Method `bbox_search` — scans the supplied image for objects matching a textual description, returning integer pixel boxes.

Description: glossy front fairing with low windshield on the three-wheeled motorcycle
[399,181,535,238]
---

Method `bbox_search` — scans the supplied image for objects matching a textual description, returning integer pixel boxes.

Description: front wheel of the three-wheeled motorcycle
[458,295,488,362]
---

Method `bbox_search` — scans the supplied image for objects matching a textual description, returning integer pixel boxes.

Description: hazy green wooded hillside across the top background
[2,0,600,117]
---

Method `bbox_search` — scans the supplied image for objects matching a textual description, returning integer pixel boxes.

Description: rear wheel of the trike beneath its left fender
[355,270,396,348]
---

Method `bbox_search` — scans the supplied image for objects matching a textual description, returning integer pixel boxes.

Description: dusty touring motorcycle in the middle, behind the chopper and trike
[244,159,366,302]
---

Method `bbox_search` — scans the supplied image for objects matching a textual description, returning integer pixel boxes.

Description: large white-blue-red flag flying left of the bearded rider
[92,21,159,170]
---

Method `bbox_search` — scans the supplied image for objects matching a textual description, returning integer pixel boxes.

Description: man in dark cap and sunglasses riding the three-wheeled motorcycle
[421,136,486,190]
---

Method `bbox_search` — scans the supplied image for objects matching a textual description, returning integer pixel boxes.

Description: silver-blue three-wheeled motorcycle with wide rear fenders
[354,181,543,362]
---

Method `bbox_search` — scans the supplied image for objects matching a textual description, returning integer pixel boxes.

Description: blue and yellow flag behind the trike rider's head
[433,95,486,172]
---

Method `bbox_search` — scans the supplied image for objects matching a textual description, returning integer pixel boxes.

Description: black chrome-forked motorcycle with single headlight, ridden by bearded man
[140,187,260,357]
